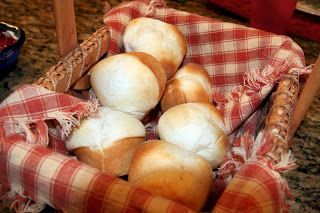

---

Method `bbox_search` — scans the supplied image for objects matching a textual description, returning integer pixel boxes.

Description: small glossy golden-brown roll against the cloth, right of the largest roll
[161,63,212,112]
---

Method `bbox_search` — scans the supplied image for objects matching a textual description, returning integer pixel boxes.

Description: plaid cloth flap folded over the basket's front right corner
[212,159,292,213]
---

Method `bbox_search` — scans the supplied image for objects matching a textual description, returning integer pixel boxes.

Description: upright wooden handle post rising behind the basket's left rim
[52,0,78,57]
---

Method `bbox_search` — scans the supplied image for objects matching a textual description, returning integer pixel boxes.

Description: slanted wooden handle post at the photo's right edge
[289,55,320,138]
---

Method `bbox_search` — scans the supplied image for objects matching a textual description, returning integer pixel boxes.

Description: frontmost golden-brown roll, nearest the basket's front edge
[128,140,213,211]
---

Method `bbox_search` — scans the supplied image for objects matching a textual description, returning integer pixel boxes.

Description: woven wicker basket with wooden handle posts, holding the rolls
[6,0,319,211]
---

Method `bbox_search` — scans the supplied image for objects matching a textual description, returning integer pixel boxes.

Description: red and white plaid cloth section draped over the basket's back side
[104,0,305,211]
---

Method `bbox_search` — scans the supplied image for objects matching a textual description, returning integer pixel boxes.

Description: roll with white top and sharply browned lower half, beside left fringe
[66,107,146,176]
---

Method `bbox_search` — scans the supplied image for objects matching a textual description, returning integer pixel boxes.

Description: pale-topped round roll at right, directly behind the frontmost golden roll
[158,103,228,169]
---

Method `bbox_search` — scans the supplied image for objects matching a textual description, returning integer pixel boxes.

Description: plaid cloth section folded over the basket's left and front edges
[0,85,191,212]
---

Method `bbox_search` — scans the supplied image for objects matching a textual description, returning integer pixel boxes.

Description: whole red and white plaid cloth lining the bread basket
[0,0,304,212]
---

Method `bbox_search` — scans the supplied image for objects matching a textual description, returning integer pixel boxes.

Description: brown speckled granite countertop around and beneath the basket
[0,0,320,212]
